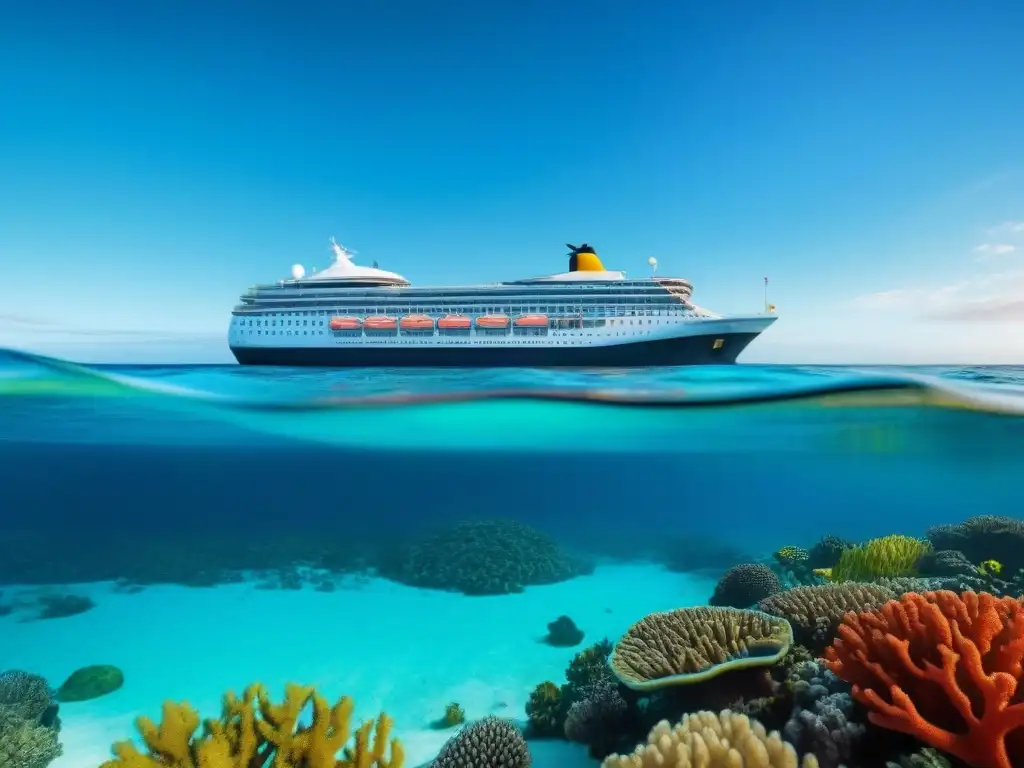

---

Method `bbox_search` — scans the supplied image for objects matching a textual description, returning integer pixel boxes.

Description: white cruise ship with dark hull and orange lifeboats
[228,238,776,368]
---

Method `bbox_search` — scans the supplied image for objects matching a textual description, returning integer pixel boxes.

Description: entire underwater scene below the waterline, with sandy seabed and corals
[0,351,1024,768]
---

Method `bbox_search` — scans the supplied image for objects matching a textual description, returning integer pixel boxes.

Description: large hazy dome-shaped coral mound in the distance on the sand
[382,518,591,595]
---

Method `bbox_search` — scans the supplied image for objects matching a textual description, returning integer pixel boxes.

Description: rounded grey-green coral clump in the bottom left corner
[0,670,63,768]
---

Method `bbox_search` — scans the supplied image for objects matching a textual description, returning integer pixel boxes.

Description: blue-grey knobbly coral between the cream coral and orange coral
[782,659,866,768]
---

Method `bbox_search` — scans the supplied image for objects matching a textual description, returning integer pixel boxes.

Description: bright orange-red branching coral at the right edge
[825,592,1024,768]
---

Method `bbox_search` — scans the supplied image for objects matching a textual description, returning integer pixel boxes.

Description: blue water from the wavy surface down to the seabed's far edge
[0,353,1024,581]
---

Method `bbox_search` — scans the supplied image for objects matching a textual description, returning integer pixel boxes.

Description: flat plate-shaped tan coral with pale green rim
[609,606,793,690]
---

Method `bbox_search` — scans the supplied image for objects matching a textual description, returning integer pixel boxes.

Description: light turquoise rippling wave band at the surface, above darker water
[0,350,1024,453]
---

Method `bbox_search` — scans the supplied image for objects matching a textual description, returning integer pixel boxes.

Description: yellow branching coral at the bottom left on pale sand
[100,683,404,768]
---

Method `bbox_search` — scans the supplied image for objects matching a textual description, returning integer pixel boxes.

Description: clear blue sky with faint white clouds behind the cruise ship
[0,0,1024,362]
